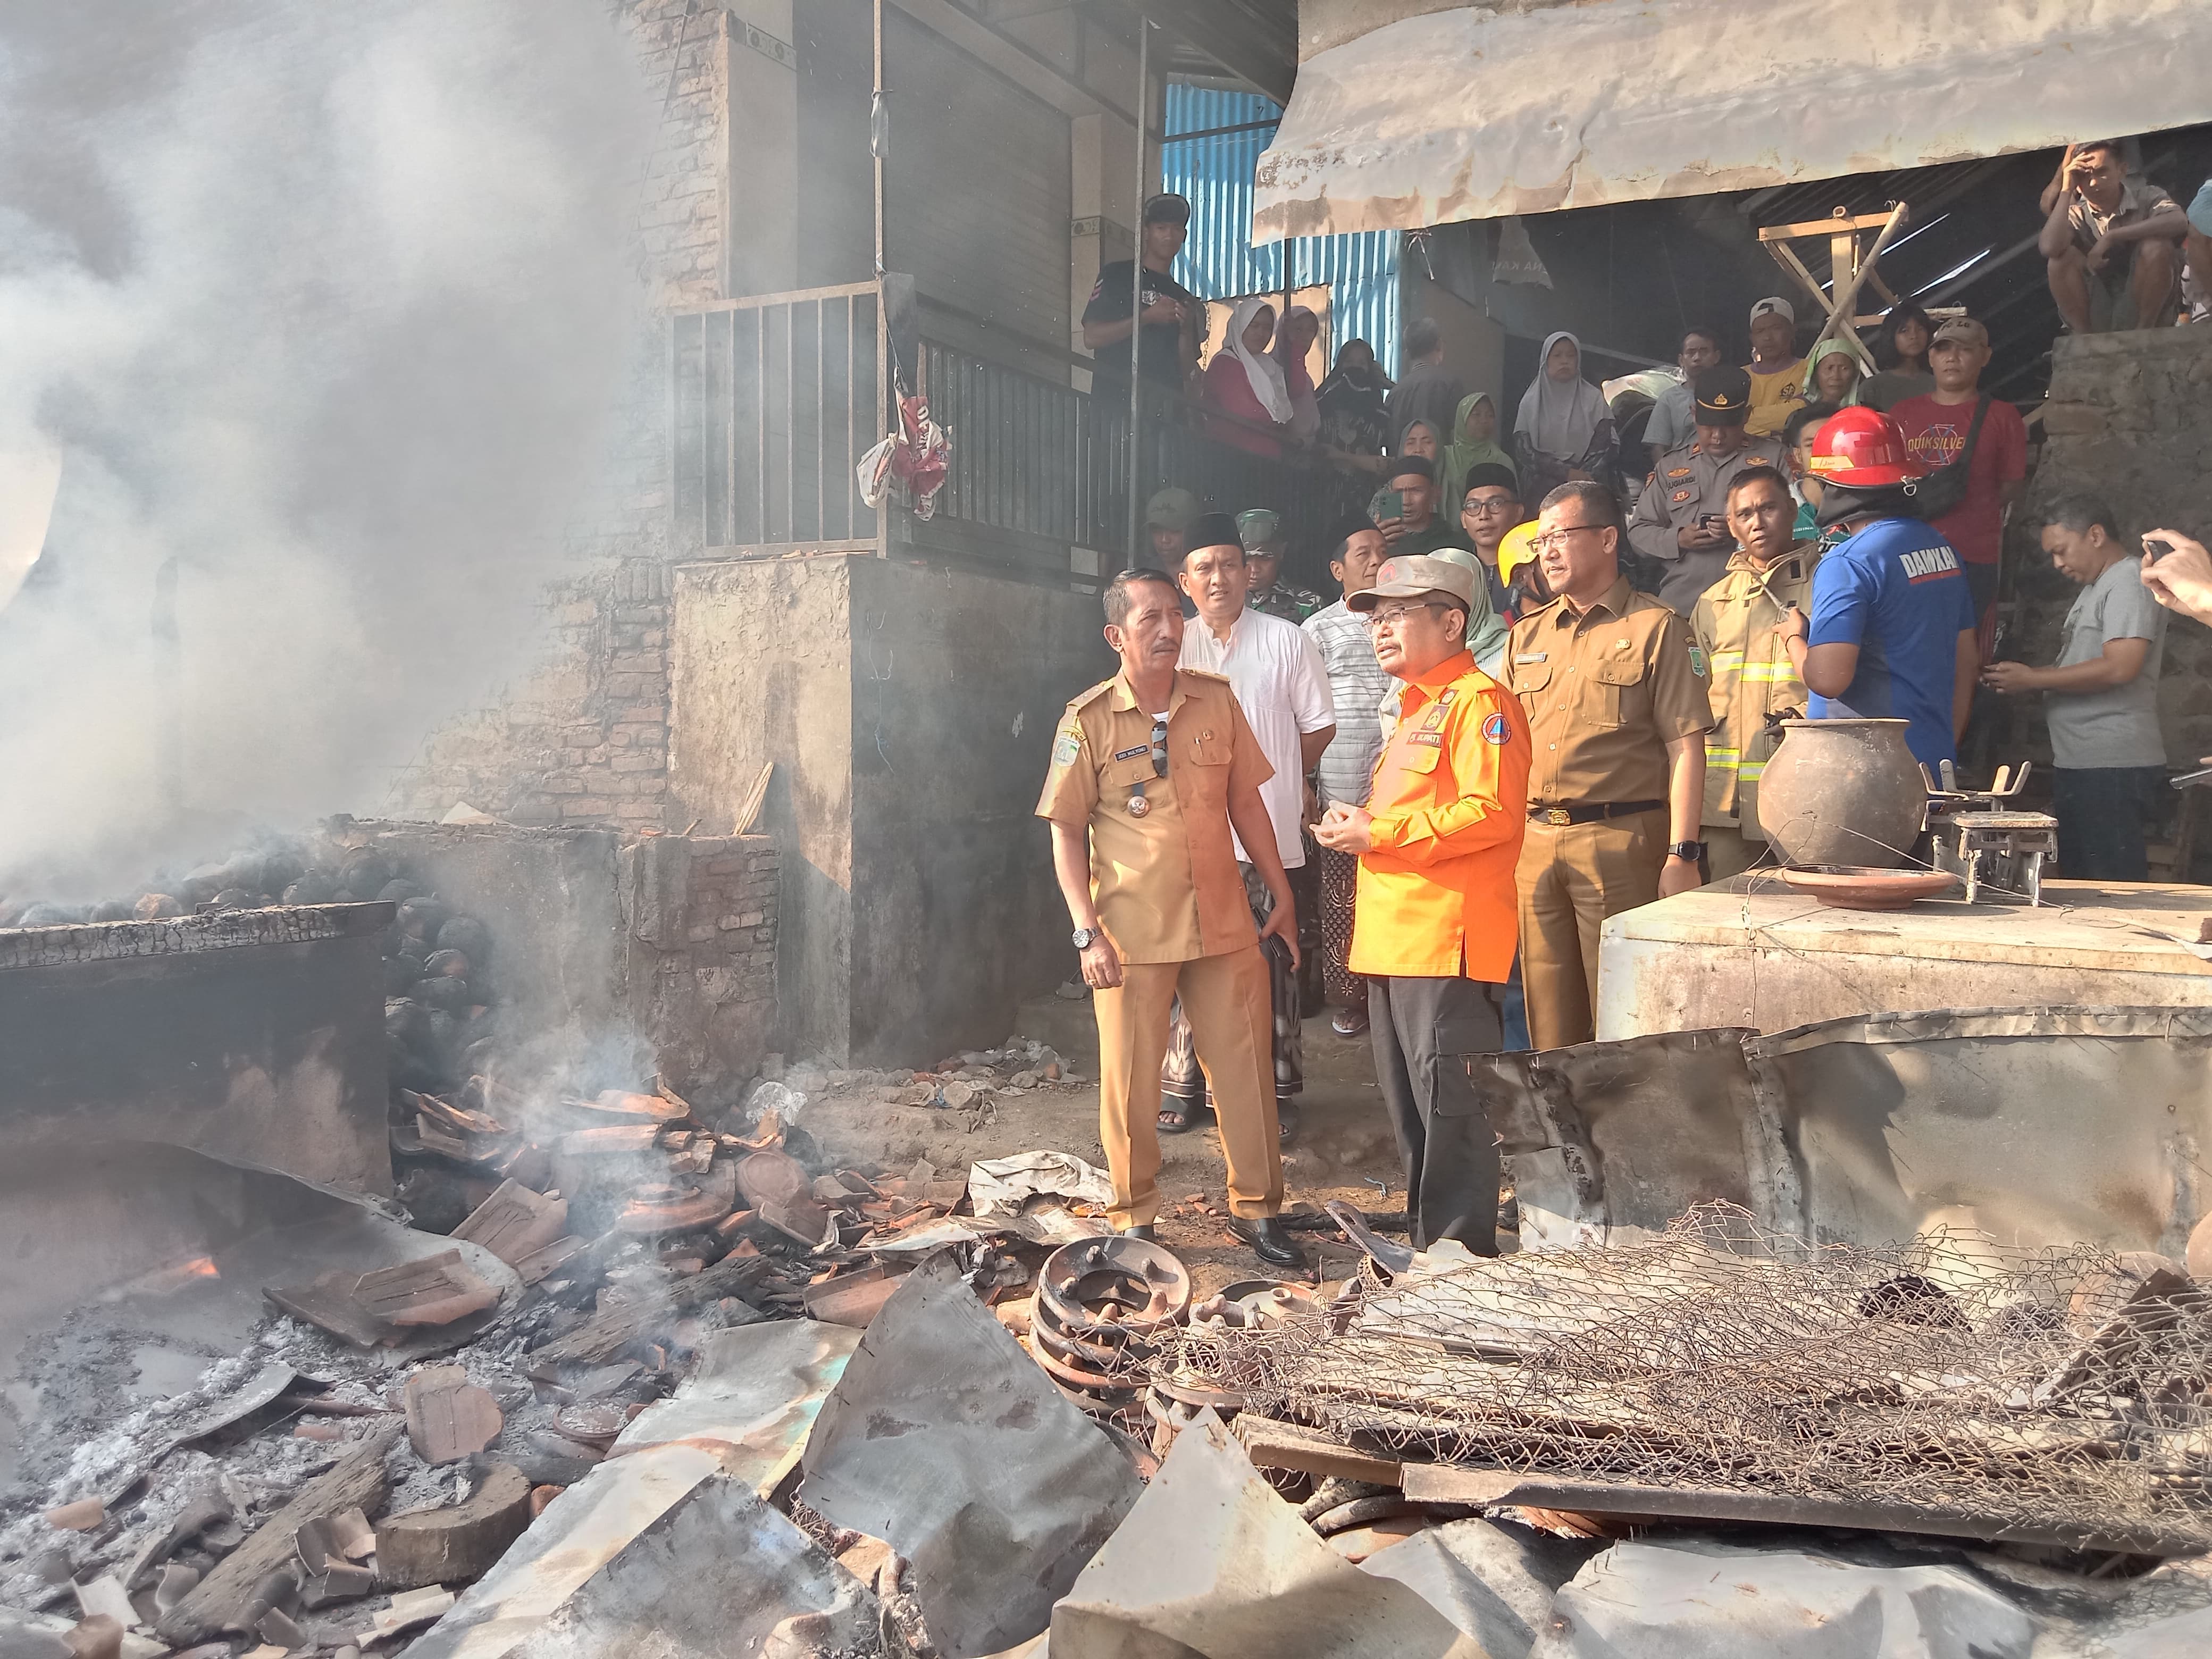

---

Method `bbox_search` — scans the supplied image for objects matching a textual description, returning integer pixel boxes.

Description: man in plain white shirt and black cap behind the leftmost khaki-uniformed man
[1159,513,1336,1139]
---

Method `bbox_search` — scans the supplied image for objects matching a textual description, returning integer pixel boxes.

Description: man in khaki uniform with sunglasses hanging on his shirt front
[1037,568,1305,1268]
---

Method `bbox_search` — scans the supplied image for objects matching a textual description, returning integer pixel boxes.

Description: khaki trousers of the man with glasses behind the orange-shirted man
[1518,807,1668,1049]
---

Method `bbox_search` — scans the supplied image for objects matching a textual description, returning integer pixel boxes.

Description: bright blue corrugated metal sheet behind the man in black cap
[1161,82,1400,374]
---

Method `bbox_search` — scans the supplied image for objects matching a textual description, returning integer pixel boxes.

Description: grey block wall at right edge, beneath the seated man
[1997,328,2212,787]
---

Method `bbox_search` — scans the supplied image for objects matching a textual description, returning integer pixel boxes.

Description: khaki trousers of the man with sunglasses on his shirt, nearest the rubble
[1091,944,1283,1228]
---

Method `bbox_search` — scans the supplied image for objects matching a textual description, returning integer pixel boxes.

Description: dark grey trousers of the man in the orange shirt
[1367,978,1504,1256]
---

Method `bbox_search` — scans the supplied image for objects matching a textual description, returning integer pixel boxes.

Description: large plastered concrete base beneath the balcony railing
[670,555,1112,1066]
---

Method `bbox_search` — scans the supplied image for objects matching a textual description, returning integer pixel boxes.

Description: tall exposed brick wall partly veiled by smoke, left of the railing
[385,0,728,830]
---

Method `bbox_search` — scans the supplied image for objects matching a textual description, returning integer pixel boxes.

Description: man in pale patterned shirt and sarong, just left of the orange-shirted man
[1298,513,1394,1037]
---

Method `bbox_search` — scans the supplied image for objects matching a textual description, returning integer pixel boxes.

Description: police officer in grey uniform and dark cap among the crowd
[1628,367,1787,617]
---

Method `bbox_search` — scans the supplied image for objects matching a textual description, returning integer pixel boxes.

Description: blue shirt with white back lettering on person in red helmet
[1805,517,1973,768]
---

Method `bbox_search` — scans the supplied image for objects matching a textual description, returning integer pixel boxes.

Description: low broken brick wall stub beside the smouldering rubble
[622,836,778,1104]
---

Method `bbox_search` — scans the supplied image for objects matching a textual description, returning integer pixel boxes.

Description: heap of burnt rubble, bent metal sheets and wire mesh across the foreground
[13,1194,2212,1659]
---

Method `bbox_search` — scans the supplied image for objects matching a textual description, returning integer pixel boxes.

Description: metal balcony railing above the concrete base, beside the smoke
[673,283,1331,577]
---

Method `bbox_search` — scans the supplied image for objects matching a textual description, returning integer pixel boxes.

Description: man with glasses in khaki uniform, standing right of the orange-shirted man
[1511,480,1712,1049]
